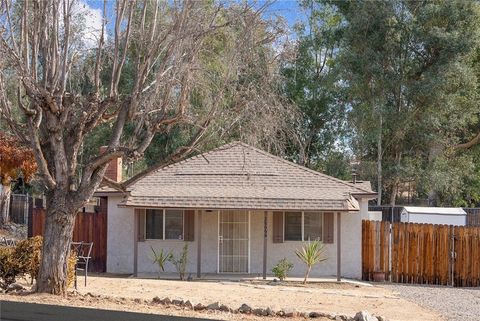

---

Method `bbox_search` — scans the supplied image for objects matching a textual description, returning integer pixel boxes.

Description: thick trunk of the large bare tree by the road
[37,191,77,295]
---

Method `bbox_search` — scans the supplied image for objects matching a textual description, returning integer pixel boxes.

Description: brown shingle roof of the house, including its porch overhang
[122,142,372,210]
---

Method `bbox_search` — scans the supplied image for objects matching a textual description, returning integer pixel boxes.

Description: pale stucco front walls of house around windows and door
[107,196,368,279]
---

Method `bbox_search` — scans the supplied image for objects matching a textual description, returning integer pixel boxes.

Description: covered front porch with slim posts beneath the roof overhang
[127,208,361,281]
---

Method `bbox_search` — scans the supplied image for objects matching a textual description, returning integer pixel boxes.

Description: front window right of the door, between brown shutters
[284,212,323,241]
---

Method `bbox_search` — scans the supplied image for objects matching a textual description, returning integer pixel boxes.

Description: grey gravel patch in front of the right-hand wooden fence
[382,284,480,321]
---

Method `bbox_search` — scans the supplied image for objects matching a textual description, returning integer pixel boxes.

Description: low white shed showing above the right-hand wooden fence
[400,206,467,226]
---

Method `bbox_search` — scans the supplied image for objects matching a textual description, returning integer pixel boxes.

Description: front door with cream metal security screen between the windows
[218,210,250,273]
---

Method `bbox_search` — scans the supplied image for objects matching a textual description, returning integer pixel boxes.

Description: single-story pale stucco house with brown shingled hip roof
[96,142,376,278]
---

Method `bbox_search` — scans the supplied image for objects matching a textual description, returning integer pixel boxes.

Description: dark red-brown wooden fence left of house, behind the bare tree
[29,197,107,272]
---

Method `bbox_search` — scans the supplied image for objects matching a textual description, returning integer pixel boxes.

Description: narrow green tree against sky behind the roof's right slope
[282,0,346,170]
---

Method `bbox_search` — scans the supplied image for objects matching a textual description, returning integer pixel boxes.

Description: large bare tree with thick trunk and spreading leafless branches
[0,0,288,294]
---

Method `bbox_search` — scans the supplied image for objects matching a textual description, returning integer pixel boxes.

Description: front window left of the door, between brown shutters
[145,209,183,240]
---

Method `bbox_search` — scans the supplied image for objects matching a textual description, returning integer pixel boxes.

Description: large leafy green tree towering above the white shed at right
[328,0,479,204]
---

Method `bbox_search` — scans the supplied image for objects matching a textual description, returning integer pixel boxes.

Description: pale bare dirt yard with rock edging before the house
[0,276,442,321]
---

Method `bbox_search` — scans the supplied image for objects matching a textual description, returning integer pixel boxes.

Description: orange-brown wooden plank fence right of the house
[362,221,480,287]
